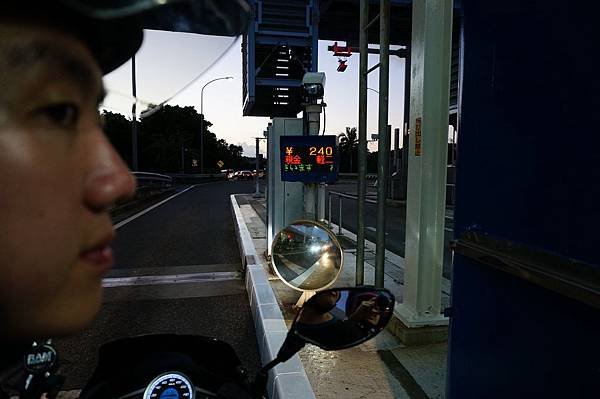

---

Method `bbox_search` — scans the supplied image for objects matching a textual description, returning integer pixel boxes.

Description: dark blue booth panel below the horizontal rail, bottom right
[446,255,600,399]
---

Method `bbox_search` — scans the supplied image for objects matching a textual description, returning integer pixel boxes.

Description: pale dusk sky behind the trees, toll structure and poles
[105,31,404,156]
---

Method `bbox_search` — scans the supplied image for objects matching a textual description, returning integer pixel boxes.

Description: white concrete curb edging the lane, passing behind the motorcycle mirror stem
[230,195,315,399]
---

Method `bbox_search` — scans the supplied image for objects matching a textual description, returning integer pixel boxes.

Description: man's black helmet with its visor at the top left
[0,0,251,74]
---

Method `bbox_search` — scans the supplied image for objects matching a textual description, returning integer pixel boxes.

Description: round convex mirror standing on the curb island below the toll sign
[271,220,344,291]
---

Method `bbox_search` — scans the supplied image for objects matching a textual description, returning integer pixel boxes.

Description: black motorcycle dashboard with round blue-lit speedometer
[80,334,241,399]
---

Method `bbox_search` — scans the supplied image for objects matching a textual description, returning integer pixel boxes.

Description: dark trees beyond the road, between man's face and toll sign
[102,105,250,173]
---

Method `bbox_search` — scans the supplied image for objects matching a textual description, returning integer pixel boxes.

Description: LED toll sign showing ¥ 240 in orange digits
[280,136,339,183]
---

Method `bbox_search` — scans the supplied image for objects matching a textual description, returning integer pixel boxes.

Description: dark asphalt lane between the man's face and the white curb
[56,182,260,390]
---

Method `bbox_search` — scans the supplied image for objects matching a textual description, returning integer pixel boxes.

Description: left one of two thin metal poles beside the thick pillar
[355,0,369,285]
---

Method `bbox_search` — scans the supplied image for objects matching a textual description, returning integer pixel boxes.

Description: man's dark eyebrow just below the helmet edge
[5,39,97,97]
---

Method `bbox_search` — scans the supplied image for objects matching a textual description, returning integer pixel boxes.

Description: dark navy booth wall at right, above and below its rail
[447,0,600,399]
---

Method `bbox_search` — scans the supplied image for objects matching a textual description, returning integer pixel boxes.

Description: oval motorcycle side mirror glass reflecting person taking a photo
[292,287,395,350]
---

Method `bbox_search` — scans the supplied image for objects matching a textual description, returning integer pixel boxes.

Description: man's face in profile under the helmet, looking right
[0,19,135,337]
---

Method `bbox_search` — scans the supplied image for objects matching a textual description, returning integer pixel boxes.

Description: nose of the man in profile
[84,137,136,212]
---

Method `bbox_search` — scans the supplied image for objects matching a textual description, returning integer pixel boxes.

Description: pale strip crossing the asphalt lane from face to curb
[102,272,241,287]
